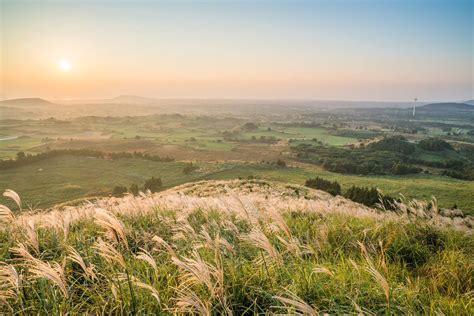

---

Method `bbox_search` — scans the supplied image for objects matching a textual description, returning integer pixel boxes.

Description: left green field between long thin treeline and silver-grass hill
[0,156,215,207]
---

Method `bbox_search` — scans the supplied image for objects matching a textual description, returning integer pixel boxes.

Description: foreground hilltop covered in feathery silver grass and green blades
[0,181,474,315]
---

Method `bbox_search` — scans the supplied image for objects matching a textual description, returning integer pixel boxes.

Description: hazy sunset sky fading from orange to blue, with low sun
[0,0,474,101]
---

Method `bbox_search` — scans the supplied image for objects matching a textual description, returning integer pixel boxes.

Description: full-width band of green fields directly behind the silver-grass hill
[0,156,474,214]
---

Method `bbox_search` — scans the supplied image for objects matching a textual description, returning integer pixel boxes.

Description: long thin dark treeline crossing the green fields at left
[0,149,174,170]
